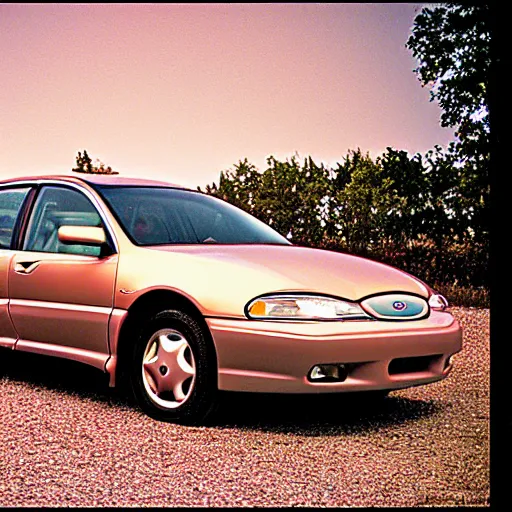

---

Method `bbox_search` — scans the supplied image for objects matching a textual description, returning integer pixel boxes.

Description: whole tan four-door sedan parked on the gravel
[0,175,462,423]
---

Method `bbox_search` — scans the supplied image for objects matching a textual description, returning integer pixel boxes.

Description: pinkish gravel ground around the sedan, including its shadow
[0,308,489,507]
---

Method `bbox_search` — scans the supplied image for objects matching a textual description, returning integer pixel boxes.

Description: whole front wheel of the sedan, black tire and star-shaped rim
[128,310,218,425]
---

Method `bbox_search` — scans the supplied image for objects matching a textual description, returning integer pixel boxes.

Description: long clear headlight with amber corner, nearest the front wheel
[245,295,371,320]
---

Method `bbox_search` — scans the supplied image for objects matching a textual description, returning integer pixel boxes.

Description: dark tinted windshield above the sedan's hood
[95,185,290,245]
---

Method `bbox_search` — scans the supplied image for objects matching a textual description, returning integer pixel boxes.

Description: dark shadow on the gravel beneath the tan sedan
[0,349,445,436]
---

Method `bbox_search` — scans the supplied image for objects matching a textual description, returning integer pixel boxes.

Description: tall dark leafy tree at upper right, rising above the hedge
[406,3,491,243]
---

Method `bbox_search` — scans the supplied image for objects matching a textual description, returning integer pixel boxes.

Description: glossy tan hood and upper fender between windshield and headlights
[120,244,429,316]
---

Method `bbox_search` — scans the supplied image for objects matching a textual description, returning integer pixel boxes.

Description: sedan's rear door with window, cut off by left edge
[0,186,30,347]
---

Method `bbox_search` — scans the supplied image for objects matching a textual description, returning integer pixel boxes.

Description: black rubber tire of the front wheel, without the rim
[128,309,217,424]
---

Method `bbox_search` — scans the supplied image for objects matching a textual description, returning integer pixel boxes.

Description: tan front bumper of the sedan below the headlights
[206,311,462,393]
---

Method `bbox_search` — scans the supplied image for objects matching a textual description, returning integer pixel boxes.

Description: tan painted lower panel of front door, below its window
[9,251,118,354]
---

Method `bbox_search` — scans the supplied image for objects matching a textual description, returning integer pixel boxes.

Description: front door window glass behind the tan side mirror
[23,186,101,256]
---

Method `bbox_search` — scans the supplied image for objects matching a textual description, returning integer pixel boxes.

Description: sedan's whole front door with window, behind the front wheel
[8,184,118,368]
